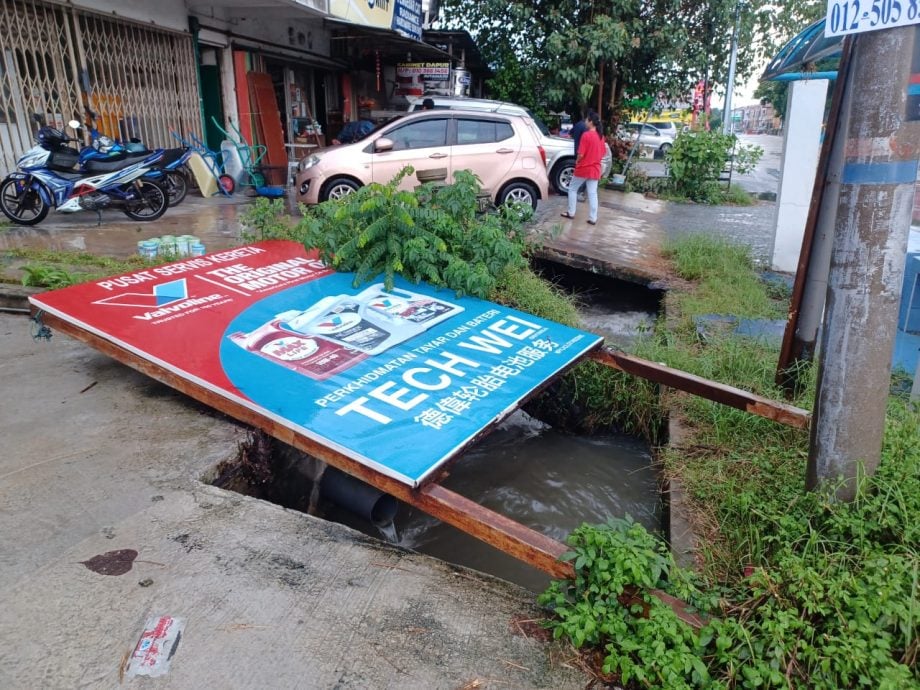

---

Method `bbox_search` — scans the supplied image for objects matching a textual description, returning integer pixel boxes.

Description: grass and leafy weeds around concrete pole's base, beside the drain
[541,232,920,690]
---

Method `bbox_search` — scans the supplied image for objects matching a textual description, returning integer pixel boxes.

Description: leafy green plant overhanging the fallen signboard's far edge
[243,167,532,297]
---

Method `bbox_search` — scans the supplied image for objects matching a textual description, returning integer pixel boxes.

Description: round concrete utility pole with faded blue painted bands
[806,26,920,500]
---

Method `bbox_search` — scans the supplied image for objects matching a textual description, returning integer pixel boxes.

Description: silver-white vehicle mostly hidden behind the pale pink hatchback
[409,96,613,194]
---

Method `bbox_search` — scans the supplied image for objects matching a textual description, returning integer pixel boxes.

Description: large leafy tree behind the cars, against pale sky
[442,0,821,119]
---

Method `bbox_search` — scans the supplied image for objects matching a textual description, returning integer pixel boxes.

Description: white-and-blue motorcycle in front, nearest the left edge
[0,119,169,225]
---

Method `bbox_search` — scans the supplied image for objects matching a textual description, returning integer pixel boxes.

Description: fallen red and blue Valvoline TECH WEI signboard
[31,241,601,486]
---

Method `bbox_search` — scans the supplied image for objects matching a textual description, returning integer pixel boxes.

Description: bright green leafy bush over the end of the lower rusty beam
[538,517,715,690]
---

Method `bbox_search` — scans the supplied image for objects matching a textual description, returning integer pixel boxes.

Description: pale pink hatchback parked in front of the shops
[295,110,549,208]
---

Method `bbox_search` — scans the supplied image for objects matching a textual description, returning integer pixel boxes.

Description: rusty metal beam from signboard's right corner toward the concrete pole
[588,349,811,429]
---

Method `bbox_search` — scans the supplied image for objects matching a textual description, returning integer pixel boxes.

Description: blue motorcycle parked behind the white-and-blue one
[77,110,193,206]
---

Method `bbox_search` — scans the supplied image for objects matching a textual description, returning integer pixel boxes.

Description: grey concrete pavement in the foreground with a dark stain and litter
[0,314,586,689]
